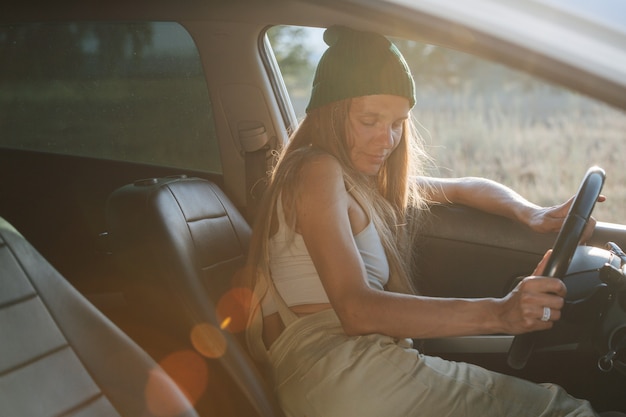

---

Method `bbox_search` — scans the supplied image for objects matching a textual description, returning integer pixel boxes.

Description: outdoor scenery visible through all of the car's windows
[0,22,626,224]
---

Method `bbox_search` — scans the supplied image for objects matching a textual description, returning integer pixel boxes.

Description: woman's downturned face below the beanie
[348,94,411,175]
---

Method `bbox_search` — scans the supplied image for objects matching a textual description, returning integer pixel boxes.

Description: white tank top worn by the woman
[262,197,389,316]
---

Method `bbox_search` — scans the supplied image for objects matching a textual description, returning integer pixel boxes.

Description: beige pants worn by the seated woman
[269,310,597,417]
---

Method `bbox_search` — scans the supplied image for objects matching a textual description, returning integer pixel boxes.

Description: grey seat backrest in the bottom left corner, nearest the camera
[0,218,197,417]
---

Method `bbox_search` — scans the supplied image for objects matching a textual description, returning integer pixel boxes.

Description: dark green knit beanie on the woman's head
[306,26,415,113]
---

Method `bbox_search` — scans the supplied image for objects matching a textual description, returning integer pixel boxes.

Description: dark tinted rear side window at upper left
[0,22,222,173]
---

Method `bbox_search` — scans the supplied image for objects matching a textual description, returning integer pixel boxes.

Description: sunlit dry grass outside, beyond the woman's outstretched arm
[414,91,626,223]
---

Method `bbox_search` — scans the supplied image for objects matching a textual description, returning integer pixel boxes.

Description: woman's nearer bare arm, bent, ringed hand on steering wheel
[296,156,565,338]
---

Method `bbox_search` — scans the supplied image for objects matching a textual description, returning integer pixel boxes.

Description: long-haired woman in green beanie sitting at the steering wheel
[248,27,596,417]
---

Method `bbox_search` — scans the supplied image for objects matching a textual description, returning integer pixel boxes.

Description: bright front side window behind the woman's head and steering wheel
[268,26,626,223]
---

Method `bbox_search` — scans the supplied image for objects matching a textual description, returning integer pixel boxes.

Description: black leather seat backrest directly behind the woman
[105,176,281,416]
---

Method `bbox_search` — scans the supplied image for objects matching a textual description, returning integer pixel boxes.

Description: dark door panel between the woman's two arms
[415,206,626,297]
